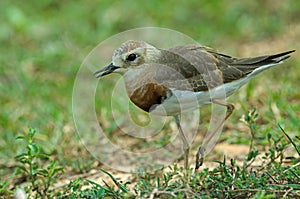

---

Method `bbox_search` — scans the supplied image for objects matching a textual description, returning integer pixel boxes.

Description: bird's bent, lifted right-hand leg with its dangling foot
[195,99,234,170]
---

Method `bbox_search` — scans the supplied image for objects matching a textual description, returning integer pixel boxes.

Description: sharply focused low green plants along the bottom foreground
[4,126,300,198]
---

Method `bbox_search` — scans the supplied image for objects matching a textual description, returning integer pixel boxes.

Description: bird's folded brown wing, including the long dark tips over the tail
[161,45,294,91]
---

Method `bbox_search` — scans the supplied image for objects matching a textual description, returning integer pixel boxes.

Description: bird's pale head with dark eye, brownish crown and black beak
[95,40,160,77]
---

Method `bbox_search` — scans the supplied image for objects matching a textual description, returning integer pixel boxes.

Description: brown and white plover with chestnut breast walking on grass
[94,40,295,170]
